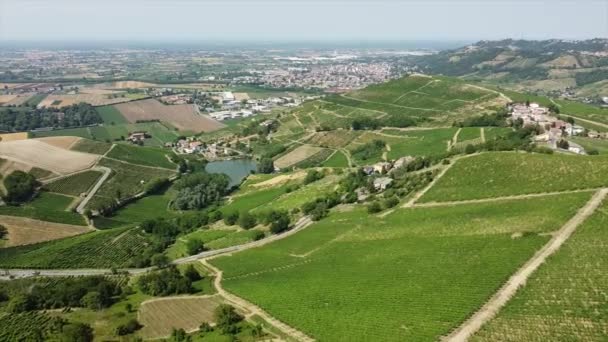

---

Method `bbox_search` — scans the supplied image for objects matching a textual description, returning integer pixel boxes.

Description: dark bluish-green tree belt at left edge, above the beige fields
[0,103,103,132]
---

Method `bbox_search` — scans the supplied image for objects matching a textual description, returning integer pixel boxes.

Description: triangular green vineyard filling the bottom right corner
[472,199,608,341]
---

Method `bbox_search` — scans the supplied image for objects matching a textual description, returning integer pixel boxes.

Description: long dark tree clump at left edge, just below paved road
[0,277,122,313]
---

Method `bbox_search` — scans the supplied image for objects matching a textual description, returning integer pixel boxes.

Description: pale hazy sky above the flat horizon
[0,0,608,41]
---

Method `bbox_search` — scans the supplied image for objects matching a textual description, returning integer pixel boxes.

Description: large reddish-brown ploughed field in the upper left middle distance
[115,99,224,132]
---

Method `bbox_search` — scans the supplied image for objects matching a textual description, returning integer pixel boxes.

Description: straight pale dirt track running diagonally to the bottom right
[444,188,608,342]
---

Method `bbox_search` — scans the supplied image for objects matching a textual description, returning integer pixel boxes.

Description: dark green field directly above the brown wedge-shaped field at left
[0,192,86,226]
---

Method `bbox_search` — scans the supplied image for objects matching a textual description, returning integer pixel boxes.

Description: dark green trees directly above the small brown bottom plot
[137,265,202,296]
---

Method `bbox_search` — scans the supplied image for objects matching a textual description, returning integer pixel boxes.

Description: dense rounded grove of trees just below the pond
[171,172,229,210]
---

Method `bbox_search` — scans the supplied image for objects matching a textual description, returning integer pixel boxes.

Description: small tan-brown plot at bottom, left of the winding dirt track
[137,296,220,339]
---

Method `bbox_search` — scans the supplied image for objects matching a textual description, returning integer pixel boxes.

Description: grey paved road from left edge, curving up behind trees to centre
[0,216,312,280]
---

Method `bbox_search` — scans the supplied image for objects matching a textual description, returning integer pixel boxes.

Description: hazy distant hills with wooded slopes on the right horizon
[415,38,608,101]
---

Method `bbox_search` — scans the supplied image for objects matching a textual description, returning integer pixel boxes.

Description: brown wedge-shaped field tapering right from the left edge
[0,216,91,247]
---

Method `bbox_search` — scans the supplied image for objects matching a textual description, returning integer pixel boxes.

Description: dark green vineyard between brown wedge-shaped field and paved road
[0,229,148,268]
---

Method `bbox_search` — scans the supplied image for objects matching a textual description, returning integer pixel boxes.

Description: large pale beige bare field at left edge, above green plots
[0,139,99,174]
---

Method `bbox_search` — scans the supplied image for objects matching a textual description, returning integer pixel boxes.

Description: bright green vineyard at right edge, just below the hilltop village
[420,152,608,202]
